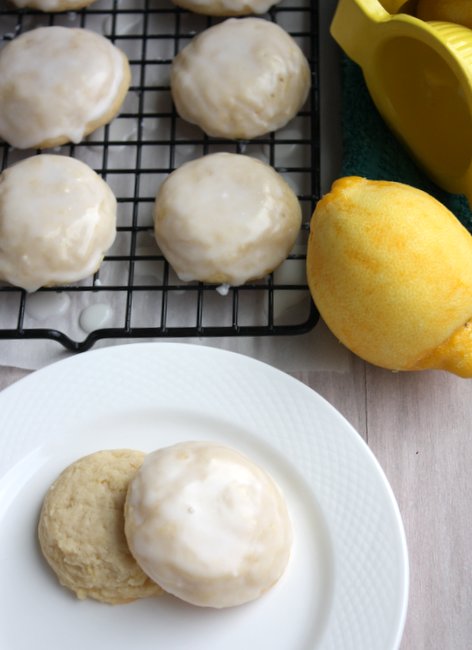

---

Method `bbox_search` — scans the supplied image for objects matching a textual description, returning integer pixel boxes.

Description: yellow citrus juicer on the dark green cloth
[331,0,472,206]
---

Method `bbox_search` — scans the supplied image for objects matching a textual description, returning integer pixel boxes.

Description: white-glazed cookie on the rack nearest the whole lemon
[154,153,301,286]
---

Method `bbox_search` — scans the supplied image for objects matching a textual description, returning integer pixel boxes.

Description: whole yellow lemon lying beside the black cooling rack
[307,176,472,377]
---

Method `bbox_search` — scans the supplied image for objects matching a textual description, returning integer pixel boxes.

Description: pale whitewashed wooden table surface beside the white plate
[0,330,472,650]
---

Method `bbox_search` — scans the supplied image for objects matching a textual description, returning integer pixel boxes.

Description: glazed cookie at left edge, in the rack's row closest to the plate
[0,154,116,291]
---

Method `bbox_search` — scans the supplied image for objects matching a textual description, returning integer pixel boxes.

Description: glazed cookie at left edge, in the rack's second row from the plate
[0,26,131,149]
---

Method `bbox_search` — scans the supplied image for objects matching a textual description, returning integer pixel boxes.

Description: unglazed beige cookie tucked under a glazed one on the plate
[38,449,162,604]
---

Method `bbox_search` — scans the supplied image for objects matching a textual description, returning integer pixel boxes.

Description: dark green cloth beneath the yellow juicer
[341,56,472,233]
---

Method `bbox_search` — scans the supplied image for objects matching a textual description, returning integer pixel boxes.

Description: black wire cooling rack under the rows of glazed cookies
[0,0,320,351]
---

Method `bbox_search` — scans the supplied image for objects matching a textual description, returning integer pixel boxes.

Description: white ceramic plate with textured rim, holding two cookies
[0,343,408,650]
